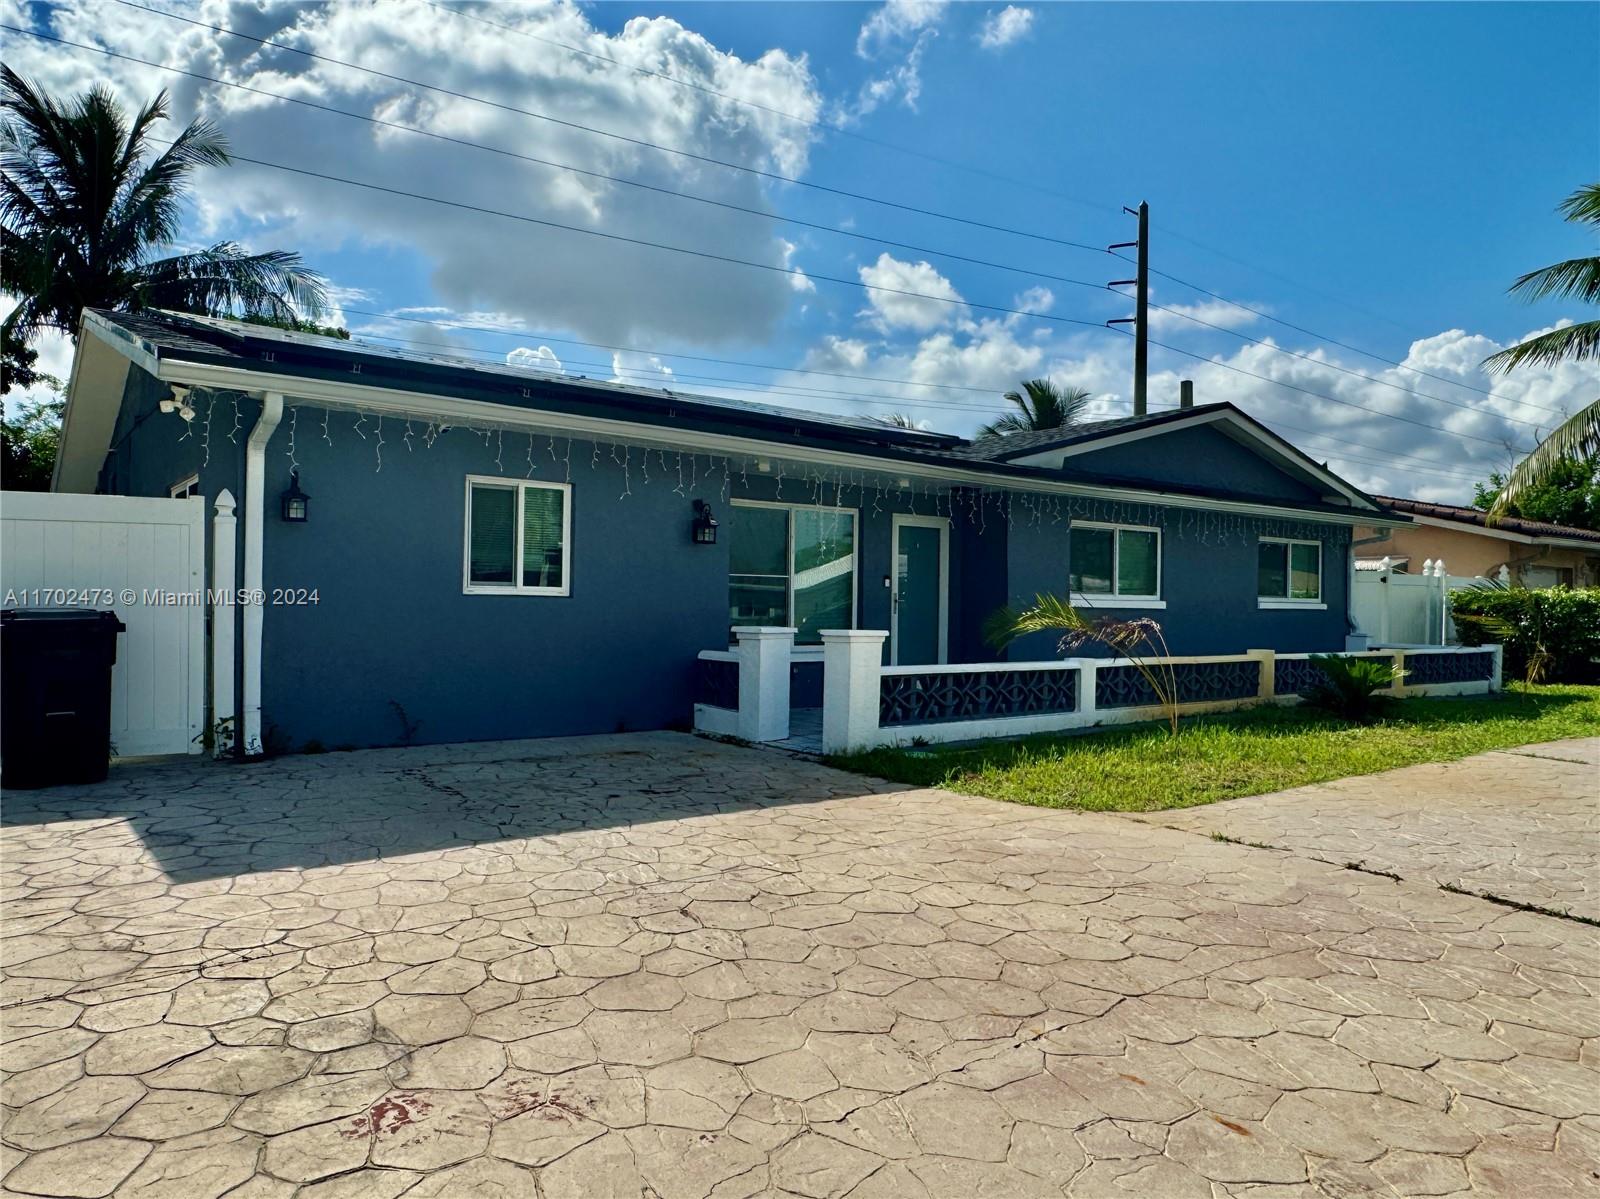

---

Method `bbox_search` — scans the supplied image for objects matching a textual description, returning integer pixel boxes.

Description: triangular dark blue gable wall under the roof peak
[1066,426,1320,503]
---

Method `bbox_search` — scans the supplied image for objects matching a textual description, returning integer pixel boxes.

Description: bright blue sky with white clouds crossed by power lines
[0,0,1600,499]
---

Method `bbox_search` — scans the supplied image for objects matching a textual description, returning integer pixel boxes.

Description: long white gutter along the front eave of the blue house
[150,362,1411,528]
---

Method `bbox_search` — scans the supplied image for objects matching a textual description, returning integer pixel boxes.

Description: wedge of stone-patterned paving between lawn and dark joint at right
[1138,736,1600,920]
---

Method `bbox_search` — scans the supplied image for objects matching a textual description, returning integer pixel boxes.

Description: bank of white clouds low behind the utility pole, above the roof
[771,319,1595,503]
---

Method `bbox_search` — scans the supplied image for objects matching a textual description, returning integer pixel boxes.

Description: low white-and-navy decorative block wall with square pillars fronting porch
[694,629,1501,754]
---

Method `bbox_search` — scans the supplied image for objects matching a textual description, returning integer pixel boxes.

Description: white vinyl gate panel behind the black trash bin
[0,491,206,757]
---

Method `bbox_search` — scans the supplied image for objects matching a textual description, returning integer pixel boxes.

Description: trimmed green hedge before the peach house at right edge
[1450,587,1600,684]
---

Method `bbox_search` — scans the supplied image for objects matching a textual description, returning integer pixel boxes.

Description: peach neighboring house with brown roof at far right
[1355,496,1600,587]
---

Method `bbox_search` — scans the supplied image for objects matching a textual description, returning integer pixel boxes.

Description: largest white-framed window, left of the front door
[725,499,858,645]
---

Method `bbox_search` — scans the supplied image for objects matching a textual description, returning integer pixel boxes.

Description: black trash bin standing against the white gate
[0,608,123,788]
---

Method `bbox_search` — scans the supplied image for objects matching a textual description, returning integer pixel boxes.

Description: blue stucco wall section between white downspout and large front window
[262,419,728,748]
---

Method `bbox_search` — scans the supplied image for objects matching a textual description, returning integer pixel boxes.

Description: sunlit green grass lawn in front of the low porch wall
[829,687,1600,812]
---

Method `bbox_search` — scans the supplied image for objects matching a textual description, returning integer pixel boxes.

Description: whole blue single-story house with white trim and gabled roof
[46,312,1405,746]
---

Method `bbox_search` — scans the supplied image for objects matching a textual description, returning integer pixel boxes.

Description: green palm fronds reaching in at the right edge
[1483,182,1600,517]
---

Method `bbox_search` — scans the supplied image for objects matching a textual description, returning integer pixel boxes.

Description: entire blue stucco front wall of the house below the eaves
[90,368,1349,748]
